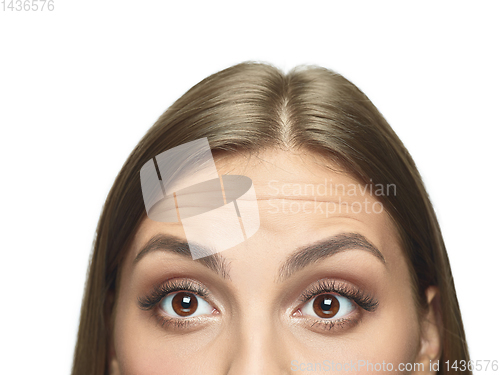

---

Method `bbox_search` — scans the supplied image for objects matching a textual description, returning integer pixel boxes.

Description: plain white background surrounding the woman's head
[0,0,500,374]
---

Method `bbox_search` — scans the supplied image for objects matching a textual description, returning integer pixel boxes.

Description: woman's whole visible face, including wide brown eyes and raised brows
[112,150,438,375]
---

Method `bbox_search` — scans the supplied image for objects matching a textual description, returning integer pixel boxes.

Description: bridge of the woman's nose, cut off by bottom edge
[227,315,290,375]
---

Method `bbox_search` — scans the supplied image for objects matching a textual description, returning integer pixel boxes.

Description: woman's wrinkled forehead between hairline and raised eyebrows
[132,149,397,270]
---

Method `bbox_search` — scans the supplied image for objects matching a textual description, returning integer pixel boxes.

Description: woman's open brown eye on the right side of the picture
[302,294,356,319]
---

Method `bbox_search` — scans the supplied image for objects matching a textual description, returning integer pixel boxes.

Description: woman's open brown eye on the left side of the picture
[160,292,213,318]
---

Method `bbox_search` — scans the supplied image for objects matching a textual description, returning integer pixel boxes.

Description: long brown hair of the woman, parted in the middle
[72,62,470,375]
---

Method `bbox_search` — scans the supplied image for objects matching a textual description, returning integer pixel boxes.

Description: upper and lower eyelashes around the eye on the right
[299,279,379,331]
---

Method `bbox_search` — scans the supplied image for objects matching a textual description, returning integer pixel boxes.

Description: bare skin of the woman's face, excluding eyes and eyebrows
[110,150,441,375]
